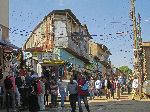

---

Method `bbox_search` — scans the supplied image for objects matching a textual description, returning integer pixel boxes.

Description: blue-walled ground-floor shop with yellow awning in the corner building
[28,48,85,80]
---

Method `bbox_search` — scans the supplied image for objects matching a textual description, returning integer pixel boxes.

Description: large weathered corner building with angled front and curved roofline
[23,9,91,79]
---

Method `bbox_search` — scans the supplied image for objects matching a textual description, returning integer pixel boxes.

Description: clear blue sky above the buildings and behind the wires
[9,0,150,68]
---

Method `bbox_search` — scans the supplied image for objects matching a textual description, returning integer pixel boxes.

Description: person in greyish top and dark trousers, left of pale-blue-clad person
[50,80,58,107]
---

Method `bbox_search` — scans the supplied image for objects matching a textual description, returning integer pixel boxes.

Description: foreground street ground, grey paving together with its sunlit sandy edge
[0,95,150,112]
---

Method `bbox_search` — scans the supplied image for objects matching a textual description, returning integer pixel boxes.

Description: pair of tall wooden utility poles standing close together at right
[130,0,143,98]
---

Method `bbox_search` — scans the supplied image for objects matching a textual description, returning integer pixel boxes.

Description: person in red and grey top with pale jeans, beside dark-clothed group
[37,76,46,111]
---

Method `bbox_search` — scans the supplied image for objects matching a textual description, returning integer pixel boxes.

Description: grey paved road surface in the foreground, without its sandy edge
[41,100,150,112]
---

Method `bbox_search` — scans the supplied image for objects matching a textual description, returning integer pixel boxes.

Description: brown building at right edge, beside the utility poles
[141,42,150,80]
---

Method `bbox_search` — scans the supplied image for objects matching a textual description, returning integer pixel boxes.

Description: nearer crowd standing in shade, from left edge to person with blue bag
[1,68,90,112]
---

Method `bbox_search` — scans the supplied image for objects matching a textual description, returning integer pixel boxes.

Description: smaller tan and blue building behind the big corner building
[89,41,111,78]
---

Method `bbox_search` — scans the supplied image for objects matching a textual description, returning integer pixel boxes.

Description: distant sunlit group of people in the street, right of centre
[89,77,122,100]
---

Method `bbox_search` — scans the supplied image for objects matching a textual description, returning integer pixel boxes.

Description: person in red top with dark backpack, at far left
[4,71,16,111]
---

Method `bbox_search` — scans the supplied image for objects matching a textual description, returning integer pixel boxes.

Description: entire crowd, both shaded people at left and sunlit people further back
[1,67,136,112]
